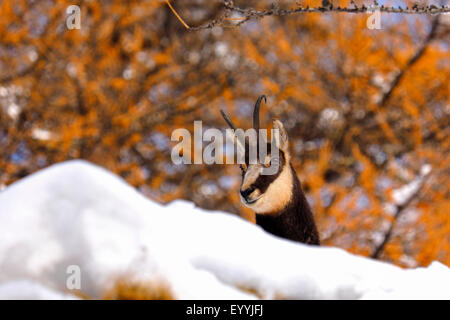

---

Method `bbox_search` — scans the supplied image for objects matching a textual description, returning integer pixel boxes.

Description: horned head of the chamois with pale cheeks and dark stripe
[221,95,293,215]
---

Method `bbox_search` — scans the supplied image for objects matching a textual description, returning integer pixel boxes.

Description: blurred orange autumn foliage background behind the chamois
[0,0,450,267]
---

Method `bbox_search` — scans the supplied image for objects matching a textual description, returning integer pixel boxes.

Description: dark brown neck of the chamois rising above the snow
[256,164,320,245]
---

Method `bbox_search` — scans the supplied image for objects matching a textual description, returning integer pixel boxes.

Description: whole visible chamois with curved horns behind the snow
[220,95,320,245]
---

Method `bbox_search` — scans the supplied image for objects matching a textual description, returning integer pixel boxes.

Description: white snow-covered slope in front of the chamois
[0,161,450,299]
